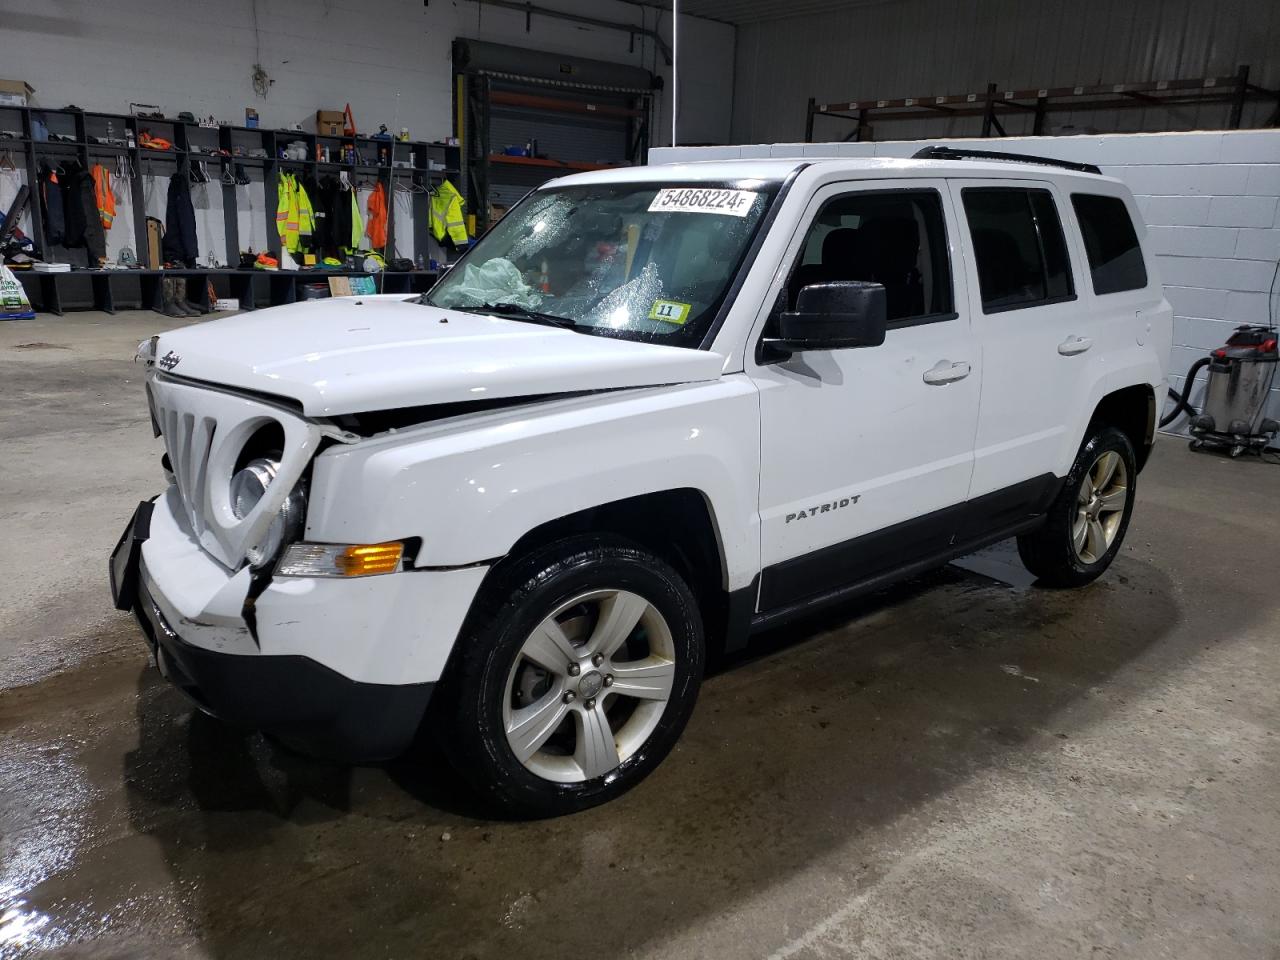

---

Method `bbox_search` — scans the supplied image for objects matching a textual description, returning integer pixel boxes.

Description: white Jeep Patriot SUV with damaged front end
[110,150,1171,815]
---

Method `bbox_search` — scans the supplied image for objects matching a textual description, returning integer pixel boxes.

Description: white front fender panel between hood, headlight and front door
[306,375,759,589]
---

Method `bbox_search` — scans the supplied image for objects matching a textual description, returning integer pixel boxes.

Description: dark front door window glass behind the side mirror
[786,189,954,326]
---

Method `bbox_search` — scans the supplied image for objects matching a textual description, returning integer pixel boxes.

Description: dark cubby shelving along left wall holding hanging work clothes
[0,105,460,314]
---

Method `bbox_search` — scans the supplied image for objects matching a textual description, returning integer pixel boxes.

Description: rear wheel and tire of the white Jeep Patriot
[1018,424,1138,586]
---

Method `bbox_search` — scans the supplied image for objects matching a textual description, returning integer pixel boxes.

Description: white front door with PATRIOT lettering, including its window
[746,179,982,612]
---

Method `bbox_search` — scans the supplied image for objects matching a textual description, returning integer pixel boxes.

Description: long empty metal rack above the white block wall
[805,65,1280,143]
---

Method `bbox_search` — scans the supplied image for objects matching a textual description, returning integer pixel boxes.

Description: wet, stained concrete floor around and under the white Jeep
[0,314,1280,960]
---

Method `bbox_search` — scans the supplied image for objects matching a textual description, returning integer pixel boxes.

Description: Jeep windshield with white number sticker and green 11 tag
[428,180,777,344]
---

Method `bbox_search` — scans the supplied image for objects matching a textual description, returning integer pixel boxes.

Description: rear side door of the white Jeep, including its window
[951,179,1100,527]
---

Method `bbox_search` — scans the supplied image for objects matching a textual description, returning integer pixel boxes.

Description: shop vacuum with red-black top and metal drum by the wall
[1160,325,1280,457]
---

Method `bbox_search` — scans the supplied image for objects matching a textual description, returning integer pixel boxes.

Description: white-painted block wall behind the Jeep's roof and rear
[650,131,1280,432]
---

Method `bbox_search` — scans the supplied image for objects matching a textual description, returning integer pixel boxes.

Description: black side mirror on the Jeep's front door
[769,280,888,352]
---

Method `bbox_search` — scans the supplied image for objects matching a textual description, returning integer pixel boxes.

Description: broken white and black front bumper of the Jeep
[110,486,485,760]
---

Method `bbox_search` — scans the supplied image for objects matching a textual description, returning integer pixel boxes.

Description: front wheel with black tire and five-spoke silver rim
[433,536,705,817]
